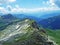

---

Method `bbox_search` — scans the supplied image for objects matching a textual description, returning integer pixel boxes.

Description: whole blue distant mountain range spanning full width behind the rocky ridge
[0,12,60,29]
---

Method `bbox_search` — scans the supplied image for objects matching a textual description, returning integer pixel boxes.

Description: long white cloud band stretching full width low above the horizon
[0,4,60,14]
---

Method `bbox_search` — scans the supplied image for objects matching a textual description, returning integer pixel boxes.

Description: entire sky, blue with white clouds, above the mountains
[0,0,60,14]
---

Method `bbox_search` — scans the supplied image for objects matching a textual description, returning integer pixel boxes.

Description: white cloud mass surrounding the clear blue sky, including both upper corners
[0,0,60,14]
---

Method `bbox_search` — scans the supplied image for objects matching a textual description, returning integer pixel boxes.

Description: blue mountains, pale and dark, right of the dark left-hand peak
[10,11,60,29]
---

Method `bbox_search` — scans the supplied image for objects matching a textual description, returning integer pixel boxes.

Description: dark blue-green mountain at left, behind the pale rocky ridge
[0,14,18,30]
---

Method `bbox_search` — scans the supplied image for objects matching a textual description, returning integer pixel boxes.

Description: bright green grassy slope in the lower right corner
[46,29,60,45]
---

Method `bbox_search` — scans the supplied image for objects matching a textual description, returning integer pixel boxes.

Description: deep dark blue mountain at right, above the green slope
[39,15,60,29]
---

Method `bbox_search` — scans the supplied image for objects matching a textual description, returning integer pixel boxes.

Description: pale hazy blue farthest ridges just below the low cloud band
[12,10,60,21]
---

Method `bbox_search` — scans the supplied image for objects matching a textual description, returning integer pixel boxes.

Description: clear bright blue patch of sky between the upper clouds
[14,0,47,8]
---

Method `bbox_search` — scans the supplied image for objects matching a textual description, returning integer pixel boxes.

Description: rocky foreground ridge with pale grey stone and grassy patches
[0,19,53,45]
